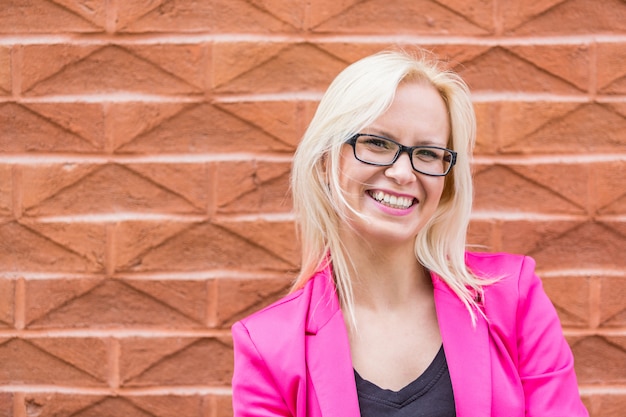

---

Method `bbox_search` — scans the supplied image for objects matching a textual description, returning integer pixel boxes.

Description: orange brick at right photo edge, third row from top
[500,102,626,153]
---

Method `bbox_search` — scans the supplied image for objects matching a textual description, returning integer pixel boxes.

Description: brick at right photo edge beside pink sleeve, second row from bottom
[570,336,626,384]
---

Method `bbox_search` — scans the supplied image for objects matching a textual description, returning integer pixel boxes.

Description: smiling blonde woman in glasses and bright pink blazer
[232,52,588,417]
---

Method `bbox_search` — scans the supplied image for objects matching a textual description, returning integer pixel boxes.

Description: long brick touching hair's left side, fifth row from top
[114,222,294,271]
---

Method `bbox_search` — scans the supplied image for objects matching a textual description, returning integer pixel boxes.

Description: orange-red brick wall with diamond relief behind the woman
[0,0,626,417]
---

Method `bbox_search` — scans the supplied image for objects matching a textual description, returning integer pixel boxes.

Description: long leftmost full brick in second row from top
[23,45,201,95]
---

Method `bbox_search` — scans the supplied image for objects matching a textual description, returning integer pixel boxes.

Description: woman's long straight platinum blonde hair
[291,51,487,325]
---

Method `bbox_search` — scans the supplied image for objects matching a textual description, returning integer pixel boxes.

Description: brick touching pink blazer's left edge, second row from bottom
[120,337,233,387]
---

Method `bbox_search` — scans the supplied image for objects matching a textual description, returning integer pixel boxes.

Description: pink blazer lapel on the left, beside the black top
[305,268,360,417]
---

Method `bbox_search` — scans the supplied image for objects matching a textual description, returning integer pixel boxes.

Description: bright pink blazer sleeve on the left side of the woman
[232,322,291,417]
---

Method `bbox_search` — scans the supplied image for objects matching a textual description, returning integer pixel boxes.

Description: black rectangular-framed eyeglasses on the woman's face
[346,133,456,177]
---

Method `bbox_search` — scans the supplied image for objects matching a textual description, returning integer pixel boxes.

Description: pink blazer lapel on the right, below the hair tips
[433,274,492,417]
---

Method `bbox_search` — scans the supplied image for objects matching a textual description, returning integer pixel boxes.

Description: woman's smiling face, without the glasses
[339,81,450,248]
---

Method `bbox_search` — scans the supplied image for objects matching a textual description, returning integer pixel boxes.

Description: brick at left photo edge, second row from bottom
[0,338,106,387]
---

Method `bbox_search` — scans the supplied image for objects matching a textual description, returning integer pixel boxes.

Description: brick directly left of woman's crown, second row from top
[213,42,346,94]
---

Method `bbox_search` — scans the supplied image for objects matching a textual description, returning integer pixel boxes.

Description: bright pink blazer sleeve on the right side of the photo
[516,257,589,417]
